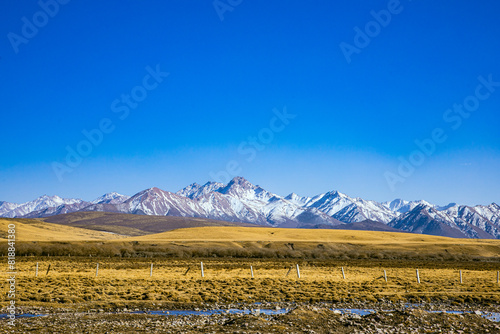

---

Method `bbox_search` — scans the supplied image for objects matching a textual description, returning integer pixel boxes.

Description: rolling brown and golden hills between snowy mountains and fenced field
[0,212,500,259]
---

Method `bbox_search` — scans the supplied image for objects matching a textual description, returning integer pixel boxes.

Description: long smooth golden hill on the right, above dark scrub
[125,226,500,257]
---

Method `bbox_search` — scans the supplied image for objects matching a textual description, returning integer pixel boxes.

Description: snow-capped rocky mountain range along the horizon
[0,177,500,239]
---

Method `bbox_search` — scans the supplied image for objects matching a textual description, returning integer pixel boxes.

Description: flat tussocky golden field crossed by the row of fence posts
[1,257,500,310]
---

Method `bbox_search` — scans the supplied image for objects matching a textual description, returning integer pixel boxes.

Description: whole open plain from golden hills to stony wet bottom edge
[0,219,500,333]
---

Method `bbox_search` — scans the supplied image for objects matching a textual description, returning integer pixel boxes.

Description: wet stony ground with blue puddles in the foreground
[0,302,500,333]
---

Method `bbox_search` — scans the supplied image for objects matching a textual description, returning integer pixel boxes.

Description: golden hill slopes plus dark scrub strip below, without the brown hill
[0,219,500,261]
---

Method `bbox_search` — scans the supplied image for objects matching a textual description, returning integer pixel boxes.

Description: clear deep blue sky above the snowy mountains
[0,0,500,205]
